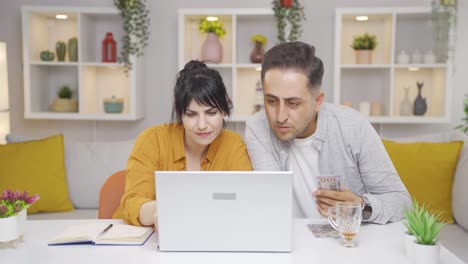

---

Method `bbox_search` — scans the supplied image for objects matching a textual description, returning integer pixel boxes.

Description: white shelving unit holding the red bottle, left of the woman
[21,6,144,121]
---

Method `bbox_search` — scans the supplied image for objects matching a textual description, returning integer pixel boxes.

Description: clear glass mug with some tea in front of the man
[328,202,362,247]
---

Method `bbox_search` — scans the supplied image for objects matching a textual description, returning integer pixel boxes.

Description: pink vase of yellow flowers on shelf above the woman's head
[198,18,226,63]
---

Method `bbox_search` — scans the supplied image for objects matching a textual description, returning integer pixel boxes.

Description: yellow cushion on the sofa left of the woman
[0,135,73,214]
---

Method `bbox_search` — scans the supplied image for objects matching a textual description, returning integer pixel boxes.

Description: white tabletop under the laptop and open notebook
[0,219,463,264]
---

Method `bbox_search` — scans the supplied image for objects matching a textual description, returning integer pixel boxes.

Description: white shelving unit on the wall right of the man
[334,7,452,124]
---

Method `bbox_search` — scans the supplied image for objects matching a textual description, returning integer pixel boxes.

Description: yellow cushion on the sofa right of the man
[383,140,463,223]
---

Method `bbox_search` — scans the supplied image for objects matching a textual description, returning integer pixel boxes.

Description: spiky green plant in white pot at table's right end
[405,201,444,264]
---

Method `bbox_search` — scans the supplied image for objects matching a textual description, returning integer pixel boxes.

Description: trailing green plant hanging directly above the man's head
[272,0,305,43]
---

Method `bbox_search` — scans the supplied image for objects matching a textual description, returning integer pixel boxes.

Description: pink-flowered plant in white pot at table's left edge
[0,189,39,247]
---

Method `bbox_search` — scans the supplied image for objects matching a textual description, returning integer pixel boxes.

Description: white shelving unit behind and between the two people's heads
[178,8,276,122]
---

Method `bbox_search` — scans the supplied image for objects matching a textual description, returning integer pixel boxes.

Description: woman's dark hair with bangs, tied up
[172,60,231,123]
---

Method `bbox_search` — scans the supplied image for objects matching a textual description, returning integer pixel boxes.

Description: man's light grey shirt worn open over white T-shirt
[245,103,411,224]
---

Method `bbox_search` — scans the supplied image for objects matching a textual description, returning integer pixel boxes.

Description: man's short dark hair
[261,41,324,90]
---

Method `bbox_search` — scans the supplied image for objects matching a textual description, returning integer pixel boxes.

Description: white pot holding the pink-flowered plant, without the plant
[0,209,27,242]
